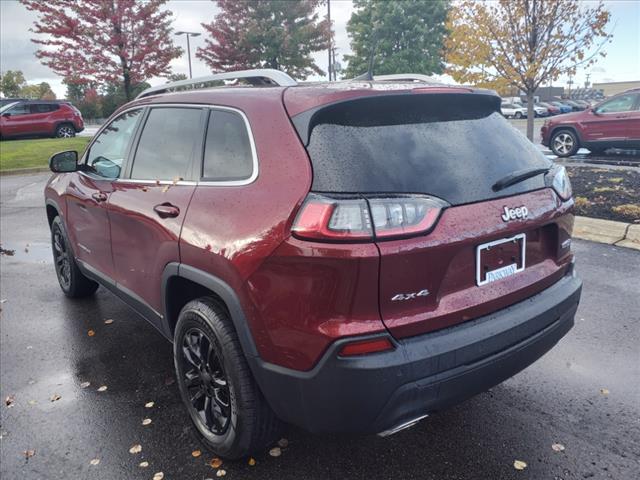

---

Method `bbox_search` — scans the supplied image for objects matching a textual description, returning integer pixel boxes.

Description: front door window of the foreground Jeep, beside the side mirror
[86,110,142,178]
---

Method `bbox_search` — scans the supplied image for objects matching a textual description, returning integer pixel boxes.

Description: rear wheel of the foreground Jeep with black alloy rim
[173,298,282,459]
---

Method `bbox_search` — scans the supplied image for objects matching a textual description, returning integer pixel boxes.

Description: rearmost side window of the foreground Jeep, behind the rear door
[202,110,253,181]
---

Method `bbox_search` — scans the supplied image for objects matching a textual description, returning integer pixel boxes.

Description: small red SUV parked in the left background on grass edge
[0,100,84,138]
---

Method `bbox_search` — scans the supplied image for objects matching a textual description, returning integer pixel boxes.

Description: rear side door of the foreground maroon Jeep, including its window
[109,106,206,314]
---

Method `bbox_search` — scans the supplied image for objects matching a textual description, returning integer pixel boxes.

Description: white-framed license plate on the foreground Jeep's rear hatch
[476,233,527,287]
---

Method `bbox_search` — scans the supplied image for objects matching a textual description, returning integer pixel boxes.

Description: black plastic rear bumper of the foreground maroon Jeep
[253,274,582,433]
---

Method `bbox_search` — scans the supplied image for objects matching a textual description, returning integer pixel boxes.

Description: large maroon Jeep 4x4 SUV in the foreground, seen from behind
[45,70,581,458]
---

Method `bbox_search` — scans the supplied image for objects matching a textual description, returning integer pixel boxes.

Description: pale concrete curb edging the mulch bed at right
[573,216,640,250]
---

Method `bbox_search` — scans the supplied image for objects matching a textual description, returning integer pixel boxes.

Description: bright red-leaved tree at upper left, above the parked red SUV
[20,0,182,101]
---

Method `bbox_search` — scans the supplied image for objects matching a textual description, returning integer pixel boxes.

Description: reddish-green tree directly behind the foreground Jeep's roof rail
[196,0,332,79]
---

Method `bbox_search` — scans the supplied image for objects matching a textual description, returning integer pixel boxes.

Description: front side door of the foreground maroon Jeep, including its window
[66,109,142,279]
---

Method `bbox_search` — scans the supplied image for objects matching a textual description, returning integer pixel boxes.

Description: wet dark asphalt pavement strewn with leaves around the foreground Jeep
[0,175,640,480]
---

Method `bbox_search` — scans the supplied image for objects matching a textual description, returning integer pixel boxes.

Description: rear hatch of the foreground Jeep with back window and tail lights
[293,91,572,337]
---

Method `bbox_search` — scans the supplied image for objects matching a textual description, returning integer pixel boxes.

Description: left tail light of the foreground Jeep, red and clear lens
[292,194,449,242]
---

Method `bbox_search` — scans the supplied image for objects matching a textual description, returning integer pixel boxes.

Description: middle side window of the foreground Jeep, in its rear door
[131,108,202,180]
